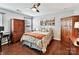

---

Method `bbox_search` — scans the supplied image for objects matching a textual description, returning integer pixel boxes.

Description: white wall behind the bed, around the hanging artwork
[33,7,79,40]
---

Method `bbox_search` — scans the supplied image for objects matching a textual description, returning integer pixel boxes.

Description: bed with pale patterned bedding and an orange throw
[21,30,53,53]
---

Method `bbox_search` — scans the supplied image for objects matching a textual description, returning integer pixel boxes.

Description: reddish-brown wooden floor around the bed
[0,40,79,55]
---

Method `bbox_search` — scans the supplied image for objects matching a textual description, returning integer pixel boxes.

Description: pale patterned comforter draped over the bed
[21,32,53,53]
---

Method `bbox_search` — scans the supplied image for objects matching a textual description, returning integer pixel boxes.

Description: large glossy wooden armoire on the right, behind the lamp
[61,15,79,46]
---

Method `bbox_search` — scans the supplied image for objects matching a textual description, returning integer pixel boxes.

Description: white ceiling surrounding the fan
[0,3,79,16]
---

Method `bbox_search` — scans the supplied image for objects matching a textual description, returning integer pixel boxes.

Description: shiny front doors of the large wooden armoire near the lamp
[61,17,72,46]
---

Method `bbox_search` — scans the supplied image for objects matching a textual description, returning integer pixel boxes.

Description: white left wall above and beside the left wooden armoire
[0,8,32,32]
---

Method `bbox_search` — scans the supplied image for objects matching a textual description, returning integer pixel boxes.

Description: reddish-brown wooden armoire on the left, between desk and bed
[11,19,25,43]
